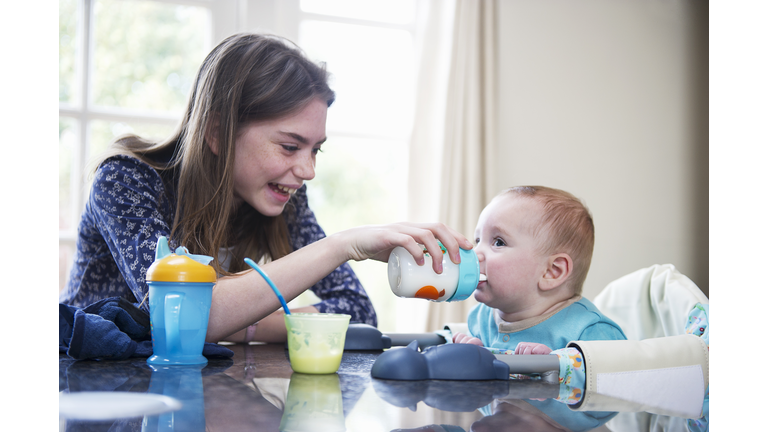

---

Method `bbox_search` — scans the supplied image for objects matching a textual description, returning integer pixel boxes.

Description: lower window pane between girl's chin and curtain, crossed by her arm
[307,136,408,329]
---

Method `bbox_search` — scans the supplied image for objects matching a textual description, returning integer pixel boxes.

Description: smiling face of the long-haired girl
[234,99,328,216]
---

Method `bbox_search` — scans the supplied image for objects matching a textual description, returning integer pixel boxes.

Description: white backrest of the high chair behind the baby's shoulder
[594,264,709,340]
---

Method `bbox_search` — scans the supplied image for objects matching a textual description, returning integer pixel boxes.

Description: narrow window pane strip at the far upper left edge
[59,0,79,104]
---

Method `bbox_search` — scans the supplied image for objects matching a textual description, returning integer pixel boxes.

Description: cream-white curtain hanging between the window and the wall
[408,0,497,331]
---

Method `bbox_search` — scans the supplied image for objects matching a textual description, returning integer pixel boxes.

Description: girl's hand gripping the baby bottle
[334,223,472,273]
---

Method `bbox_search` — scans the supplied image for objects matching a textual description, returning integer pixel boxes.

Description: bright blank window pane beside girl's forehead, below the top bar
[299,21,415,138]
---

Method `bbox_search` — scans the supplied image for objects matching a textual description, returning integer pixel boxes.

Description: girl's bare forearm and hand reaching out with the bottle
[206,223,472,342]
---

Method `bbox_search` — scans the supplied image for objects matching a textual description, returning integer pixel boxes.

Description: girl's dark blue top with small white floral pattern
[59,156,377,326]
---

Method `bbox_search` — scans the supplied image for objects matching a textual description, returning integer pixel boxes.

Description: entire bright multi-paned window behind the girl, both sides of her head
[59,0,418,331]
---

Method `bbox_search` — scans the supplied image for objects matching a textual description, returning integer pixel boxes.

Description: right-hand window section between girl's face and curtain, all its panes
[297,0,417,331]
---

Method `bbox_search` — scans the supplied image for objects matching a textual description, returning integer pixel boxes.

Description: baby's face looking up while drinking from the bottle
[474,195,547,314]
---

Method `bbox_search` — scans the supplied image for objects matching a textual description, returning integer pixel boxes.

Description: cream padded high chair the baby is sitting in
[569,264,709,426]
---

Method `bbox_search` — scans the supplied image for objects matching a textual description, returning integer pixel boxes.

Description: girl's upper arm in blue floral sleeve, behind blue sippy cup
[79,156,172,312]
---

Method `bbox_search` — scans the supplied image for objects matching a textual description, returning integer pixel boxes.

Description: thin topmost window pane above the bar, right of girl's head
[301,0,416,24]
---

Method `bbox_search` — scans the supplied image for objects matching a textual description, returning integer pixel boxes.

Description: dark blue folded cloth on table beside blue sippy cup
[59,297,234,360]
